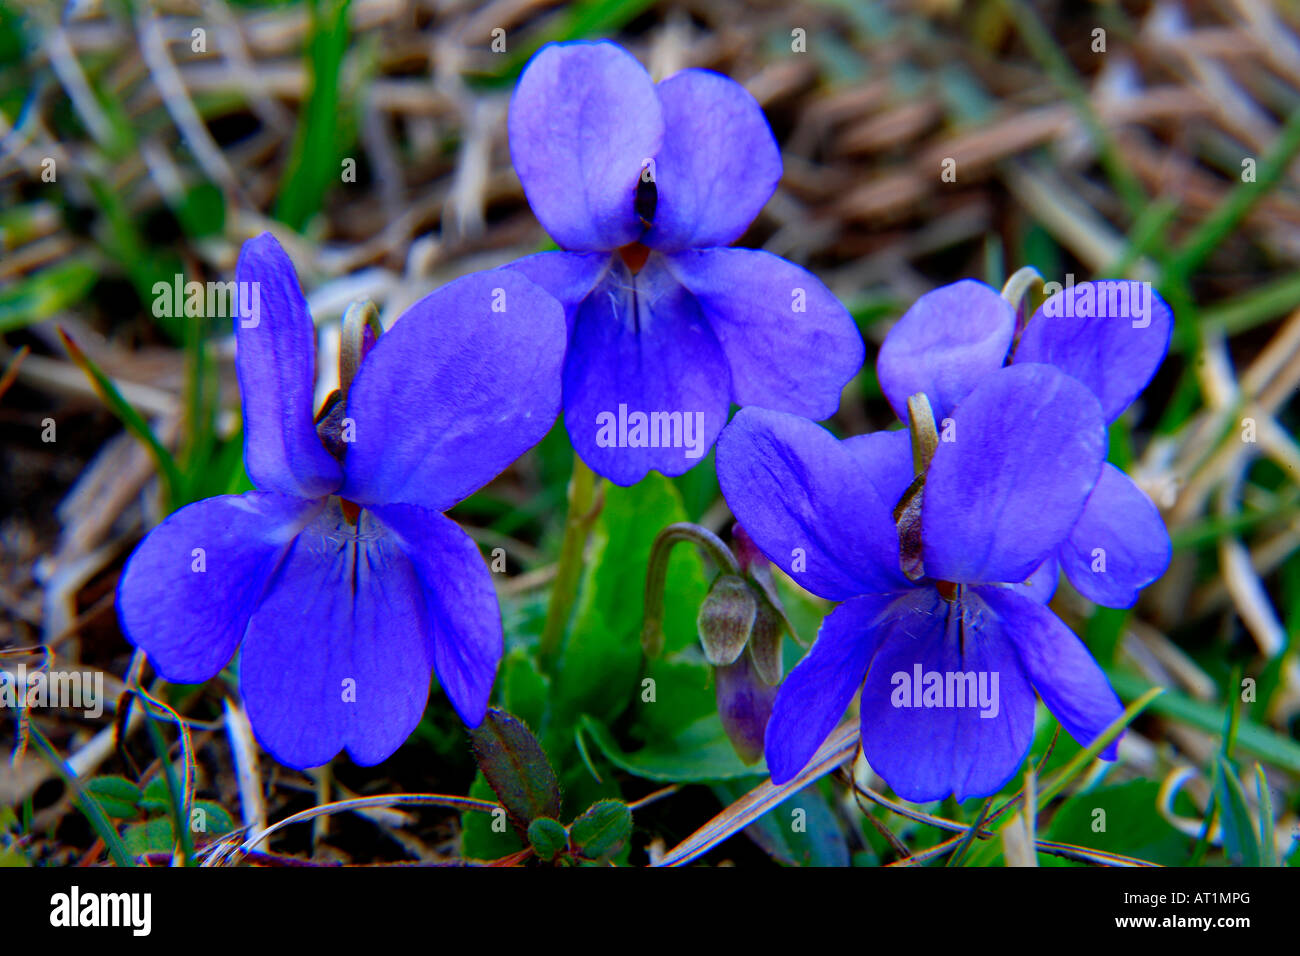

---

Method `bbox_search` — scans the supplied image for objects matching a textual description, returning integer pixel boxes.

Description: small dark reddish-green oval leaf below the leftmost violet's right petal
[469,708,560,830]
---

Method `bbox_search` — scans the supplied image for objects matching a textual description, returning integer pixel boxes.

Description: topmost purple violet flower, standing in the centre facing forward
[499,42,865,485]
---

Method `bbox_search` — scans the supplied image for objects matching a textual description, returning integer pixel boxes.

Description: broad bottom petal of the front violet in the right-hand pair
[861,588,1034,801]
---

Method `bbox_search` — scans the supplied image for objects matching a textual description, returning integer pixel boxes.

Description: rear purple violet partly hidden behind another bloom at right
[876,280,1174,607]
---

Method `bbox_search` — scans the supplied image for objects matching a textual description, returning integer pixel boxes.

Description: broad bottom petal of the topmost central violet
[564,255,731,485]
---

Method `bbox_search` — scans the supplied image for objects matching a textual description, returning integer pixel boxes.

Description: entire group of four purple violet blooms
[118,42,1173,800]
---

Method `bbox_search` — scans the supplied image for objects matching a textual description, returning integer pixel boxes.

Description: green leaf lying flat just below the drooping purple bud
[581,714,767,783]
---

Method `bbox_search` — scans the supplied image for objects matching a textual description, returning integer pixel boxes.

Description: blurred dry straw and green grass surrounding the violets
[0,0,1300,864]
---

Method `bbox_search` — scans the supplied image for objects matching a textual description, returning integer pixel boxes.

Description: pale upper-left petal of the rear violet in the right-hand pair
[876,278,1015,421]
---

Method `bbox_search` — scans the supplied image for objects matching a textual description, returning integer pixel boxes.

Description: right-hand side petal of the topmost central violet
[666,248,865,419]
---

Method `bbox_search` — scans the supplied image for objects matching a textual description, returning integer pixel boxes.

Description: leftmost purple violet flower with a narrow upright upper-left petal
[117,234,564,767]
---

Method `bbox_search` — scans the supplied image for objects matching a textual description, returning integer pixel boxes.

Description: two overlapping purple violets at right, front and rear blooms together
[718,282,1173,800]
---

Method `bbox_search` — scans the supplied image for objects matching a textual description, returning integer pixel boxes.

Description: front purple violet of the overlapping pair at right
[718,363,1122,801]
